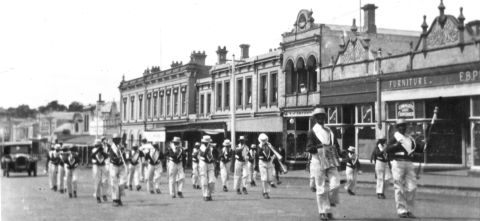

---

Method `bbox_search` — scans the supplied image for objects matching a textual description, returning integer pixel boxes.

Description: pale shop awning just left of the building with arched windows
[227,116,283,132]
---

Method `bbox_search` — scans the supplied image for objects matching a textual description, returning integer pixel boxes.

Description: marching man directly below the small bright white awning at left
[141,139,163,194]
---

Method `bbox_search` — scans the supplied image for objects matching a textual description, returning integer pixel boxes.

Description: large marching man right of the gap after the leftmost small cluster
[91,140,108,203]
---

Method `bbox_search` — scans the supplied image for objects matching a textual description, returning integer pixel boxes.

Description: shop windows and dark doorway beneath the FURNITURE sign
[388,97,470,164]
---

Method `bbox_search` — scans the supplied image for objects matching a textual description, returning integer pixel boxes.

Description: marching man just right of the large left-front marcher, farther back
[126,146,143,191]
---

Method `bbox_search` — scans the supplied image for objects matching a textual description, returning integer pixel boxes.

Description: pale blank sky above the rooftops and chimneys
[0,0,480,108]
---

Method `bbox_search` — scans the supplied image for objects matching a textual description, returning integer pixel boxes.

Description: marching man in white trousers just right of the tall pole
[233,136,249,195]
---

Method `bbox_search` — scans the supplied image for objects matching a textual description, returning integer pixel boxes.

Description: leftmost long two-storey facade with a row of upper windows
[119,51,210,151]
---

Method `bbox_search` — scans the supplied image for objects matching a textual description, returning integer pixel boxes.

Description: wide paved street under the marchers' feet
[0,169,480,221]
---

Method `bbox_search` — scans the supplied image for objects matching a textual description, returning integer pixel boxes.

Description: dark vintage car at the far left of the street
[0,141,38,177]
